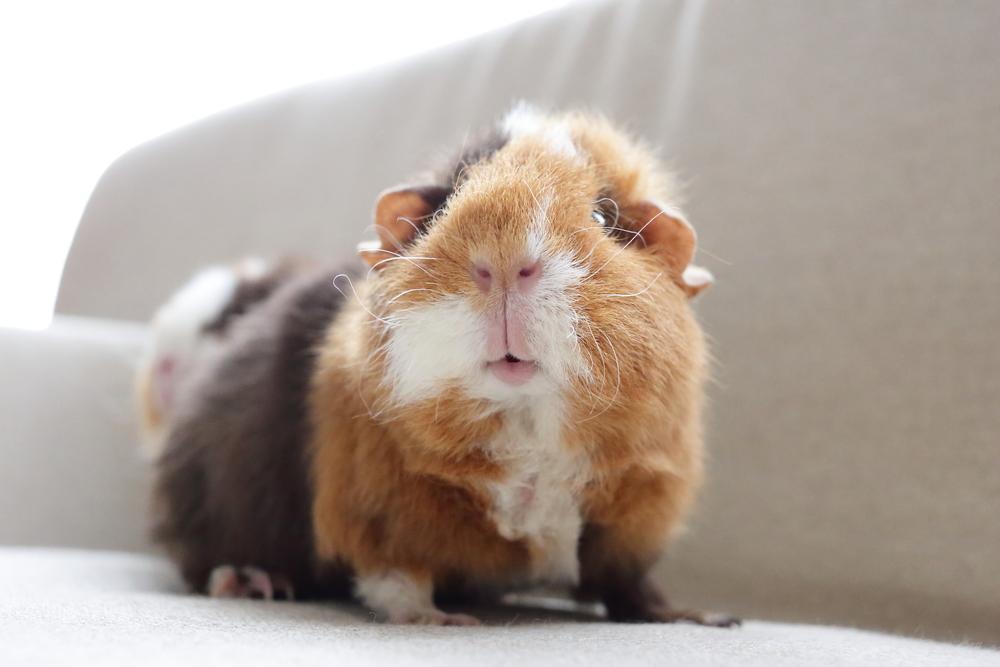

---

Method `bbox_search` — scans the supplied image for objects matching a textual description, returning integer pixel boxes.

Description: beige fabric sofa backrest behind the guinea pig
[58,0,1000,642]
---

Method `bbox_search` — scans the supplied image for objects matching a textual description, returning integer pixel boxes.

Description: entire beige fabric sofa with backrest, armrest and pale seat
[0,0,1000,665]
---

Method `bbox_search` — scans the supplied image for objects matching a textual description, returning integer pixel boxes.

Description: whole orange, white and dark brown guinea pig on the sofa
[143,106,736,625]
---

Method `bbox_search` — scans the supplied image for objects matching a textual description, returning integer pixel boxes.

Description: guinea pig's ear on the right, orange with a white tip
[621,200,714,297]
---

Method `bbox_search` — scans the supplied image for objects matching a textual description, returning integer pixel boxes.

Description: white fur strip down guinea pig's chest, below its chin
[489,402,587,584]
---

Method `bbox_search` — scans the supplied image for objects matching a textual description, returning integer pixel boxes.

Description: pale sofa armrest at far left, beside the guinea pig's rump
[0,316,151,552]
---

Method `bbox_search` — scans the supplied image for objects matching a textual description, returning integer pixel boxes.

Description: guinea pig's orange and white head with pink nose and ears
[359,107,711,418]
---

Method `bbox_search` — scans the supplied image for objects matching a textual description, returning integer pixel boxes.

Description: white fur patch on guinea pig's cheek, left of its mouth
[386,296,486,404]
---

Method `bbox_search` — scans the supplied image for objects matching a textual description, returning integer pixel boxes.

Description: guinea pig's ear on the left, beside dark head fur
[358,185,448,269]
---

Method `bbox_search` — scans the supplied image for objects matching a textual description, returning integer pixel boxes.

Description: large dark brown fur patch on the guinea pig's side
[148,273,347,597]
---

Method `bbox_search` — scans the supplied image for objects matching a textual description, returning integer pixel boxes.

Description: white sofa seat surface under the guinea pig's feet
[0,548,1000,667]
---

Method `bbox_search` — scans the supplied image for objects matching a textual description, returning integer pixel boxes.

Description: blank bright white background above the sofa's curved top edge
[0,0,569,329]
